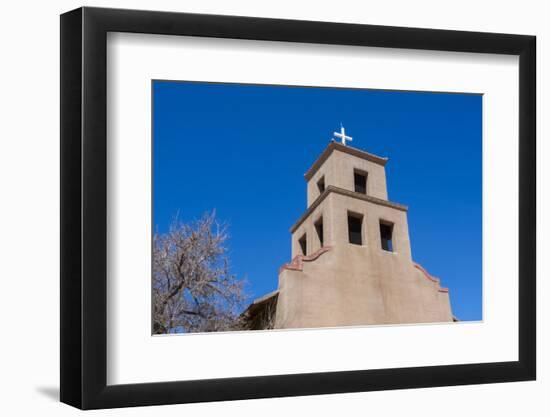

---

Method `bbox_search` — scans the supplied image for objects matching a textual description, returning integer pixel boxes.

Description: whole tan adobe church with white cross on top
[242,127,453,330]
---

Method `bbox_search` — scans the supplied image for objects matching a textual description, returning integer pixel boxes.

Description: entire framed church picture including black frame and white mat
[61,7,536,409]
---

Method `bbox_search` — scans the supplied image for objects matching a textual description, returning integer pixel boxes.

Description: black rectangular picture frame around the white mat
[60,7,536,409]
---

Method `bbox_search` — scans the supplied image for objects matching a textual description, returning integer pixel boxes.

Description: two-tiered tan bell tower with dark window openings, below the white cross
[290,138,411,259]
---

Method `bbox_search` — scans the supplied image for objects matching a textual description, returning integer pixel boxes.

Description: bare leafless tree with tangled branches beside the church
[152,212,245,334]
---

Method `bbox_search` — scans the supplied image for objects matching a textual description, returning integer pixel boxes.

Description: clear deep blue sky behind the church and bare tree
[153,81,482,320]
